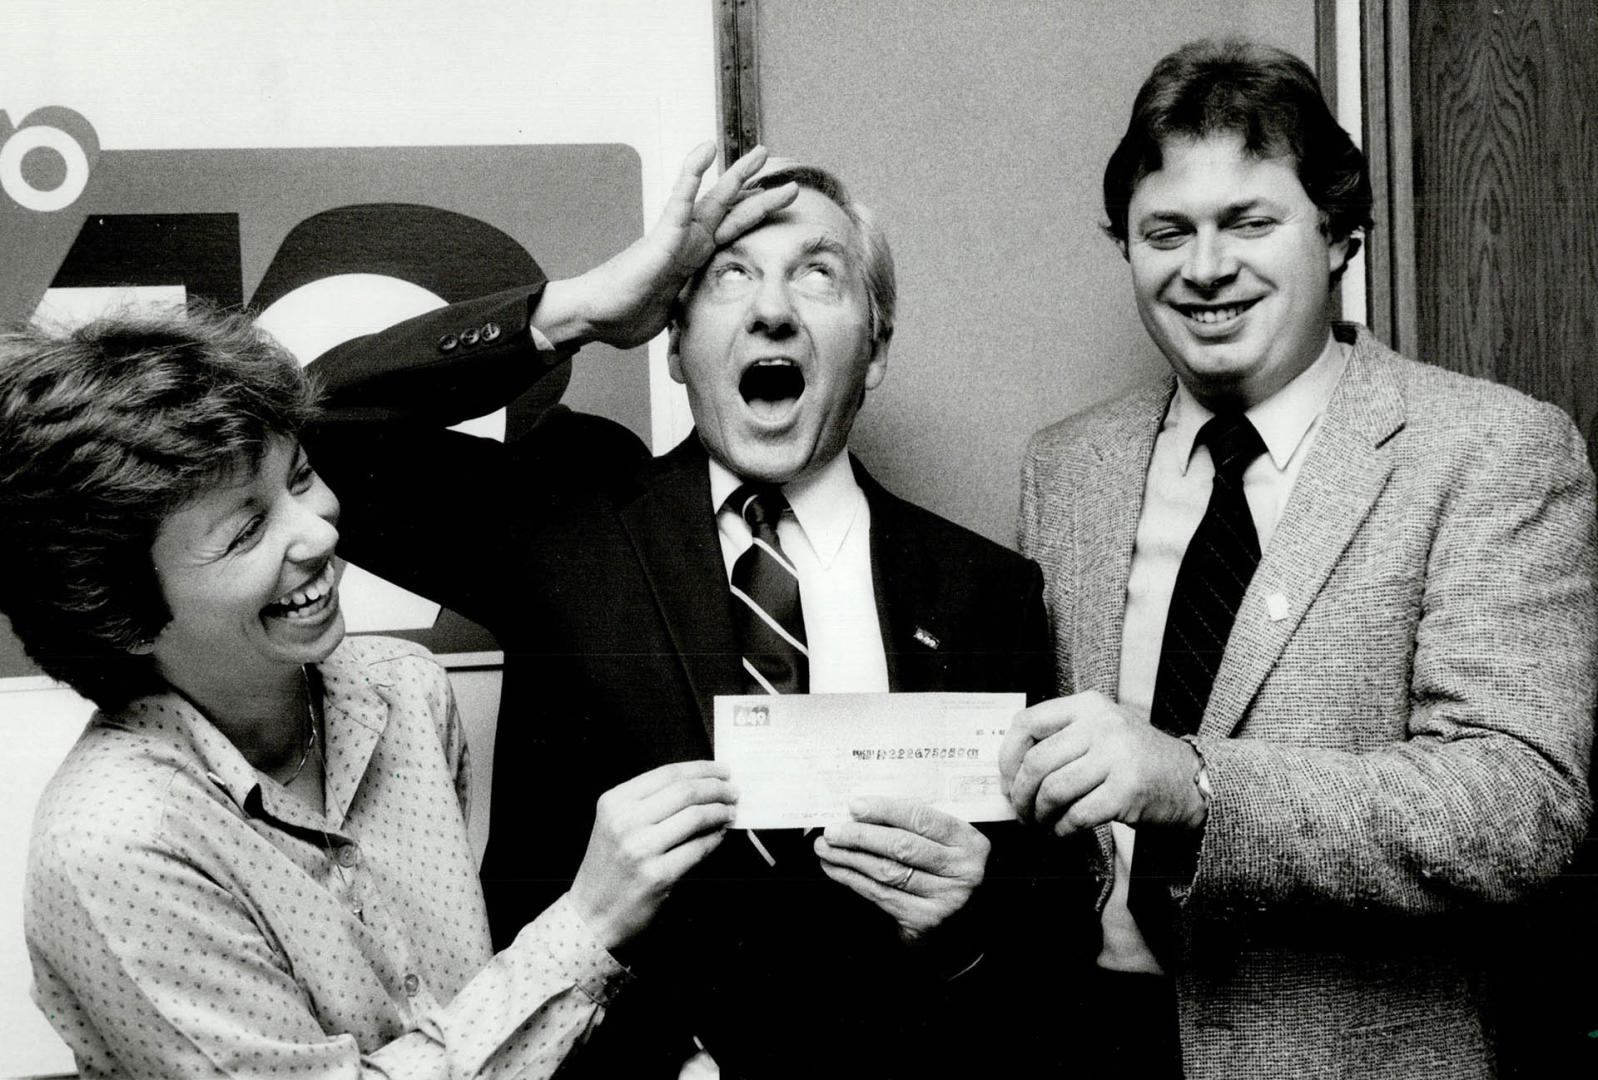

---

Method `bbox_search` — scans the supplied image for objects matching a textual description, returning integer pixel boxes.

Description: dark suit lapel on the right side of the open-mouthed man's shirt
[849,455,948,690]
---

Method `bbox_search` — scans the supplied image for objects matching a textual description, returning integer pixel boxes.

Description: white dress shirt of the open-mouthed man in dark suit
[710,454,888,693]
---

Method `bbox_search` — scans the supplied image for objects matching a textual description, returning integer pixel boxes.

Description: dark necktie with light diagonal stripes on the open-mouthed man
[725,484,810,693]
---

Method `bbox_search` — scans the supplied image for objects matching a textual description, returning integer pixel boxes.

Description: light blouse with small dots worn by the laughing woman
[24,637,630,1077]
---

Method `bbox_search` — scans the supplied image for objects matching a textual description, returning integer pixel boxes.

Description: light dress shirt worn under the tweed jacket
[1098,334,1349,973]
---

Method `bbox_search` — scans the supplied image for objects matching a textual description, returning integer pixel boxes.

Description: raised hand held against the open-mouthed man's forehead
[532,142,799,348]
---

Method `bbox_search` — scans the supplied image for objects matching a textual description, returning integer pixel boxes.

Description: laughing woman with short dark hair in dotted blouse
[0,310,732,1077]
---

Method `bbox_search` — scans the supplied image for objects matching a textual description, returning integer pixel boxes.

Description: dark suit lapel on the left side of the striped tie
[622,431,741,737]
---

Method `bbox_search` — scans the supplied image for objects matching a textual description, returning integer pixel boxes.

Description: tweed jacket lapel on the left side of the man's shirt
[1071,375,1176,698]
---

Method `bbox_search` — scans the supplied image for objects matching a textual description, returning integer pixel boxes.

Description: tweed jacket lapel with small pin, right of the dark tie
[1199,332,1405,737]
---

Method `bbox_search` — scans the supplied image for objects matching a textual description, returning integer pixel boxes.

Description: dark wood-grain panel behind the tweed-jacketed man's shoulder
[1409,0,1598,460]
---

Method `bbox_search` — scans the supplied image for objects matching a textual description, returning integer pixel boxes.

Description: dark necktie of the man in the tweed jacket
[1127,412,1266,970]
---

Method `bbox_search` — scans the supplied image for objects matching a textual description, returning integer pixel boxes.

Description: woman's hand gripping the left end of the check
[570,760,737,949]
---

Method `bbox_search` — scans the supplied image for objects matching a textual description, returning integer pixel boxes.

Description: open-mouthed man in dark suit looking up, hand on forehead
[308,145,1087,1077]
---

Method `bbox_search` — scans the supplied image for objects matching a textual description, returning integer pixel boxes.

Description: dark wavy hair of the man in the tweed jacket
[1104,38,1371,265]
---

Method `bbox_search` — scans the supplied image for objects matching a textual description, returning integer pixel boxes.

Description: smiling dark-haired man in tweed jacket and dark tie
[1004,42,1595,1080]
